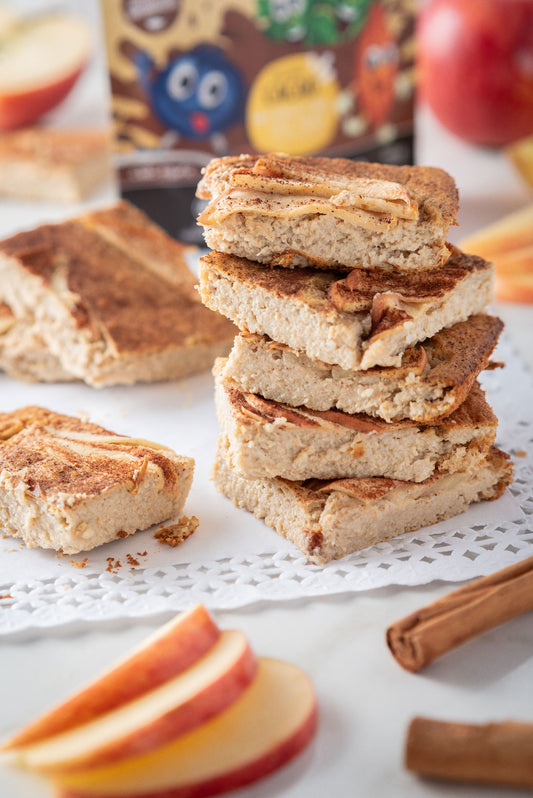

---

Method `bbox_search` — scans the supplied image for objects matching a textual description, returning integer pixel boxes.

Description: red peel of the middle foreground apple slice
[39,645,257,776]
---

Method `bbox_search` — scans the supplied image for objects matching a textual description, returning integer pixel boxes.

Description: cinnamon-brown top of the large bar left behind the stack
[0,202,234,354]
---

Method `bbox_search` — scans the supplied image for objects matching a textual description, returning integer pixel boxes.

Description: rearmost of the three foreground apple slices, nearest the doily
[2,604,220,750]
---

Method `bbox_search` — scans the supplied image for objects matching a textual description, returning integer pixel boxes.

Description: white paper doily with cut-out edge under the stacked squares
[0,332,533,633]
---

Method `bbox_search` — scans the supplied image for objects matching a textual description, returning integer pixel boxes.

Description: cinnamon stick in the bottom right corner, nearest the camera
[405,717,533,788]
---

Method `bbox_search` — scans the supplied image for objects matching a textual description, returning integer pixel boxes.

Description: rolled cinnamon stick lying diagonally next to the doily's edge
[387,557,533,672]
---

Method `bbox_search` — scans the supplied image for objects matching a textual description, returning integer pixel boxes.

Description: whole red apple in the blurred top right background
[418,0,533,146]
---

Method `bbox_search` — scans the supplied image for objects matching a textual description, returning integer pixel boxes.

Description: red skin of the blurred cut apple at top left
[0,64,86,131]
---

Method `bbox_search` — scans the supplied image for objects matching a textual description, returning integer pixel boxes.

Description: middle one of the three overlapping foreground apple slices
[13,631,257,775]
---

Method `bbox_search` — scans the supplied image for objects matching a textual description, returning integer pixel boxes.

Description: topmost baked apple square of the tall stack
[197,155,458,272]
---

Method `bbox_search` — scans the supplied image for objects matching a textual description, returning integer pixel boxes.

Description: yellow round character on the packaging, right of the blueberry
[246,53,340,155]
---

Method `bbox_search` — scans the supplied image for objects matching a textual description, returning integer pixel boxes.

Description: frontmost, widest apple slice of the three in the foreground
[54,659,317,798]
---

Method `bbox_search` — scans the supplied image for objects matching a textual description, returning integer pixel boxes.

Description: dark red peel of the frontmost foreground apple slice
[55,704,318,798]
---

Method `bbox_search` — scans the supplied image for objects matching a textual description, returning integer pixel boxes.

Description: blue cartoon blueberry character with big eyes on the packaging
[136,45,245,146]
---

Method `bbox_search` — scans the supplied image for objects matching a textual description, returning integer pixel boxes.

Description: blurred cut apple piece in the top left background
[0,13,91,130]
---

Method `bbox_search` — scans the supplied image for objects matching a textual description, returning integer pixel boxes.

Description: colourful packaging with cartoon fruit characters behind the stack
[101,0,416,241]
